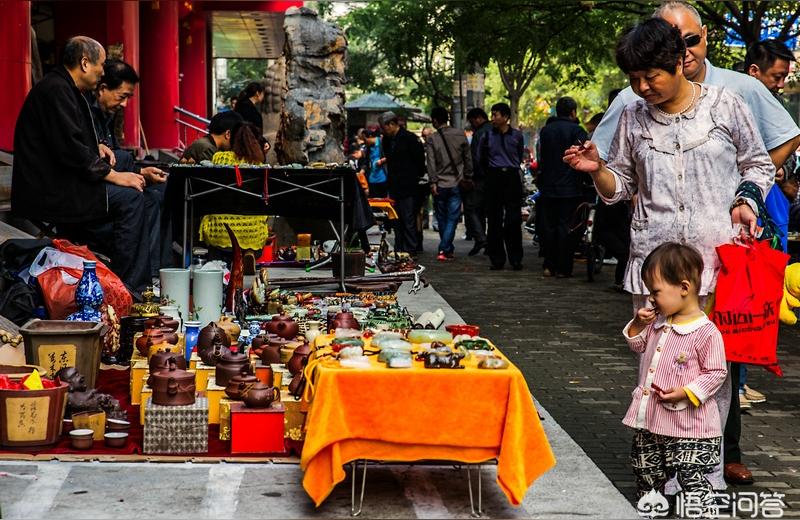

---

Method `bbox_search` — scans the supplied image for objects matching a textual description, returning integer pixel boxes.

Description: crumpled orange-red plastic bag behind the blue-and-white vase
[32,239,133,320]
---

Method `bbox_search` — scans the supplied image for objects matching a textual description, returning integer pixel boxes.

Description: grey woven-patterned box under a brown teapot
[143,397,208,453]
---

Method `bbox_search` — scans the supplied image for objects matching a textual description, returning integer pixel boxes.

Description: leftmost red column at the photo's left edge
[0,0,31,151]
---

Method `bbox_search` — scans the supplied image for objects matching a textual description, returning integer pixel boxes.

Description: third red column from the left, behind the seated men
[139,0,180,149]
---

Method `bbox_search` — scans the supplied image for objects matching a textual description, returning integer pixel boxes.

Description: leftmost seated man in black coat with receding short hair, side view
[11,36,150,290]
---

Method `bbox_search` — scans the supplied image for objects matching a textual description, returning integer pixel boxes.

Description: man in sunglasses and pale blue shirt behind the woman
[592,1,800,489]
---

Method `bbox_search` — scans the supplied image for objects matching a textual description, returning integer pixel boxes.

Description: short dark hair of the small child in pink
[642,242,703,291]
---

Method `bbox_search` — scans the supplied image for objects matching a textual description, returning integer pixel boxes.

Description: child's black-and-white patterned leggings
[631,430,721,505]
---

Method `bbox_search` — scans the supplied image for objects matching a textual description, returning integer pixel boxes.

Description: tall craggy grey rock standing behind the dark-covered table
[276,7,347,164]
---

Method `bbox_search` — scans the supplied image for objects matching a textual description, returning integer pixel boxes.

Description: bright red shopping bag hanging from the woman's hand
[711,241,789,376]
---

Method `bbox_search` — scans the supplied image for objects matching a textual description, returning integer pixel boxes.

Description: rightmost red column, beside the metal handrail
[180,10,210,145]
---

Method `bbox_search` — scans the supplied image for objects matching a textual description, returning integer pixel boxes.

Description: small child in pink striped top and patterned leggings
[622,242,727,507]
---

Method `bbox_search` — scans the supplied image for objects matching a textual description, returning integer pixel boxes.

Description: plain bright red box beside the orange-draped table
[230,402,286,454]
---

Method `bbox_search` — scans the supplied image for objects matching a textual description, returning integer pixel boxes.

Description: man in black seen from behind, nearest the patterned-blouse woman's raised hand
[536,97,587,278]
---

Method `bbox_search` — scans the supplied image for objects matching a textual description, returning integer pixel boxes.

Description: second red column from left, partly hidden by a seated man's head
[106,0,141,148]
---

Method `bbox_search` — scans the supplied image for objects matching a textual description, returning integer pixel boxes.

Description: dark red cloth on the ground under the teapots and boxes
[0,368,294,458]
